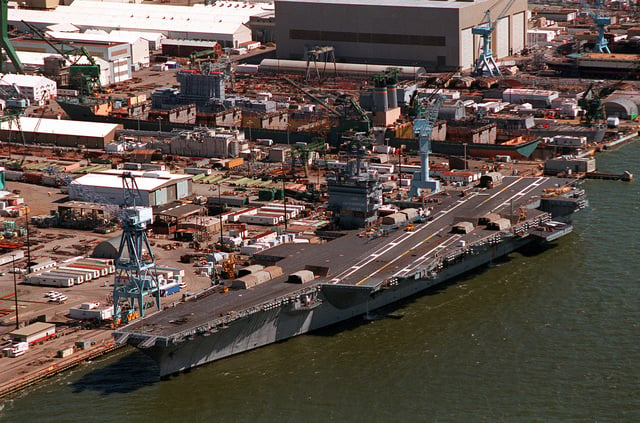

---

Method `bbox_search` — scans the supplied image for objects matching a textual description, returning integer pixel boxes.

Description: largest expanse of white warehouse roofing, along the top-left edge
[9,0,273,38]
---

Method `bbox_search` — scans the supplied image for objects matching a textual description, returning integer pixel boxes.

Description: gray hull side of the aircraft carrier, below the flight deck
[141,237,533,376]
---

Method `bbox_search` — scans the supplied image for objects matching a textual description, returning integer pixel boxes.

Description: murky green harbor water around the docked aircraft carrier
[0,141,640,423]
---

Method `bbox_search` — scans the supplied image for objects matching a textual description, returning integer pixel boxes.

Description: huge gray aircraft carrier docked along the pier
[114,177,587,376]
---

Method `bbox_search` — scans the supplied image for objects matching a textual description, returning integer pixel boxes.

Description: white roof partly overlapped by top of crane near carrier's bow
[71,169,193,192]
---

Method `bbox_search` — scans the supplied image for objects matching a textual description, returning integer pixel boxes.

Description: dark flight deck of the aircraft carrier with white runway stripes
[116,177,580,344]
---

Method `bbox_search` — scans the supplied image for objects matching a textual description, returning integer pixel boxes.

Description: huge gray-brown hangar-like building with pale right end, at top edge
[275,0,527,70]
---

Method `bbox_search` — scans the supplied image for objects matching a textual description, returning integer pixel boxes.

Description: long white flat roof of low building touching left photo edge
[0,117,119,137]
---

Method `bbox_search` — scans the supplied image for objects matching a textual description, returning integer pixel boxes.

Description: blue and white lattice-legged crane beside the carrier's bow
[113,172,160,323]
